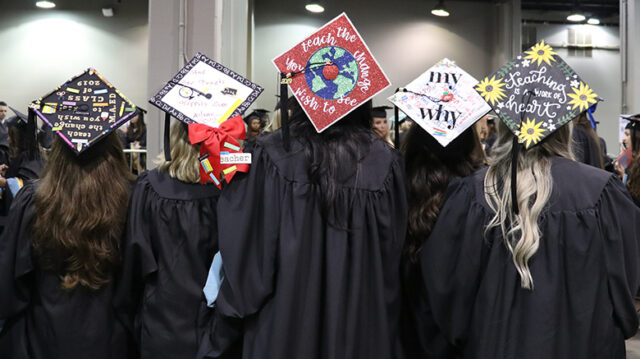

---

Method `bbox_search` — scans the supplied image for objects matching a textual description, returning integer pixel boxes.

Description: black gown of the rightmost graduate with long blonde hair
[420,158,640,359]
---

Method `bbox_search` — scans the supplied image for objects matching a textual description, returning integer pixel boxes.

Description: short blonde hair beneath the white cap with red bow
[155,121,200,183]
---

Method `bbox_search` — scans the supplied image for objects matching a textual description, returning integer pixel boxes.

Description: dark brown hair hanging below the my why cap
[402,125,484,263]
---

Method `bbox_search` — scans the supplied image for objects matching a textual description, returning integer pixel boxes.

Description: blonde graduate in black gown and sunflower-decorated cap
[420,42,640,359]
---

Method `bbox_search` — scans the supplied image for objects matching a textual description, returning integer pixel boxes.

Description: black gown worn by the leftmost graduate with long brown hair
[0,185,132,359]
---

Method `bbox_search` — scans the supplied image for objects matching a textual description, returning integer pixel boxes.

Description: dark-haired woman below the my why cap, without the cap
[402,116,484,357]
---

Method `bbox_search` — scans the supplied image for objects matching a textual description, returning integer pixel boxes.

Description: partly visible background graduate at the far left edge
[0,108,45,233]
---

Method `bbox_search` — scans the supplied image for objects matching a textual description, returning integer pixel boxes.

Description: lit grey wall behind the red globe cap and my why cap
[253,0,520,109]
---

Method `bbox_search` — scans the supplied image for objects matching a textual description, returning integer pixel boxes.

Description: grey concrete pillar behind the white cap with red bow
[145,0,249,168]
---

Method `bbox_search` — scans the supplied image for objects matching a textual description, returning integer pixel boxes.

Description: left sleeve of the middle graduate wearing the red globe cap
[216,146,286,318]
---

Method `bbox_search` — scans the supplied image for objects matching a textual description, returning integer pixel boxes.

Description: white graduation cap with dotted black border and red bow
[149,53,264,188]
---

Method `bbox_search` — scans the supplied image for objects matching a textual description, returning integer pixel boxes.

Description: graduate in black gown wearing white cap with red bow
[116,54,262,359]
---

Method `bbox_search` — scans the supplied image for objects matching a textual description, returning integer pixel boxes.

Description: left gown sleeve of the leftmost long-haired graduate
[0,186,35,320]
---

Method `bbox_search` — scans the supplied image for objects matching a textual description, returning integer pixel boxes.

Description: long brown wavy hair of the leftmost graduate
[33,133,133,290]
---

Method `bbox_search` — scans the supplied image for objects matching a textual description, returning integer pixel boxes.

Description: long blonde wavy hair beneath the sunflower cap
[484,121,573,289]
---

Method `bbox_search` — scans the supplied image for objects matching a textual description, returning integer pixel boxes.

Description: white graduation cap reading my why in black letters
[389,59,491,146]
